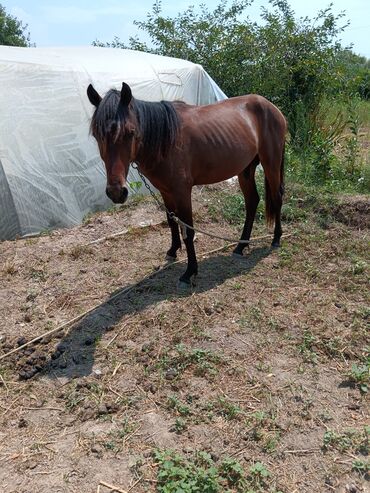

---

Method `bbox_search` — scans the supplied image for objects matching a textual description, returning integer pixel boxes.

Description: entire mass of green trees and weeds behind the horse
[94,0,370,190]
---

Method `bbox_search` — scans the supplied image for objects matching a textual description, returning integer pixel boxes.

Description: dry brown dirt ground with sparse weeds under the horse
[0,185,370,493]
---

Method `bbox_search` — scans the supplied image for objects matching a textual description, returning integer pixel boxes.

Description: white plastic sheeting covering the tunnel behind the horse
[0,46,226,240]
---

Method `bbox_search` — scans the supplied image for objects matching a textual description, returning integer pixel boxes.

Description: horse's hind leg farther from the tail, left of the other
[233,156,260,255]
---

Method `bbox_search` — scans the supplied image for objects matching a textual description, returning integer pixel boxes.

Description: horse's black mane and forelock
[90,89,180,161]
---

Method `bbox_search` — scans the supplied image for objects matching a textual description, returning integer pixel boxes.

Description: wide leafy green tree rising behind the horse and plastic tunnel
[95,0,346,147]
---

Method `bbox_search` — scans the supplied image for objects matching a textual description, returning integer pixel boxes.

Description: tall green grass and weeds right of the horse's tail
[287,97,370,193]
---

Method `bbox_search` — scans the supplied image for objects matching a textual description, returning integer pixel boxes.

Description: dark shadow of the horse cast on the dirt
[43,247,271,378]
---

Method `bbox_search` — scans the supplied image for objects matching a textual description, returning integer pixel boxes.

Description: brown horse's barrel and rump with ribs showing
[168,94,286,185]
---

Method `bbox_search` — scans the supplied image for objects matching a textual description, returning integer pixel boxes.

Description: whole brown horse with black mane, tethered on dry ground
[87,83,287,286]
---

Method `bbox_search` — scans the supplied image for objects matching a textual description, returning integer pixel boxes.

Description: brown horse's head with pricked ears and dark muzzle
[87,82,137,204]
